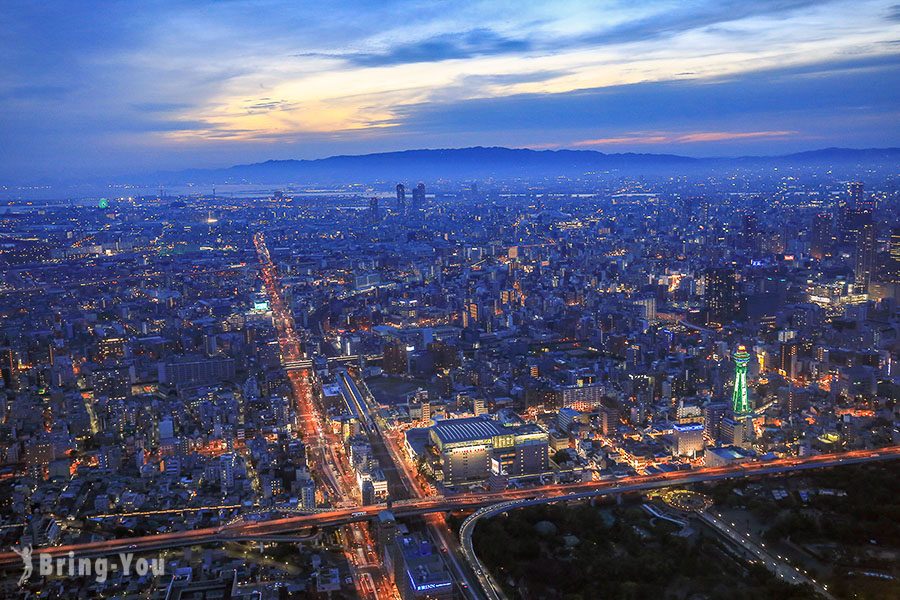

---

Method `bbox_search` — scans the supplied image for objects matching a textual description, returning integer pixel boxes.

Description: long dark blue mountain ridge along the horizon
[158,146,900,183]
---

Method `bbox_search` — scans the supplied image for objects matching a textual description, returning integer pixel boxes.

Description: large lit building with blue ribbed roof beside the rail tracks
[429,416,550,485]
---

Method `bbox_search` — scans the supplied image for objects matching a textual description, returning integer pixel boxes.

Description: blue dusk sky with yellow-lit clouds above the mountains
[0,0,900,183]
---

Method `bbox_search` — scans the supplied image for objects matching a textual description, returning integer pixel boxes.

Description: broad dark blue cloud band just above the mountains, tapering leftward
[394,56,900,147]
